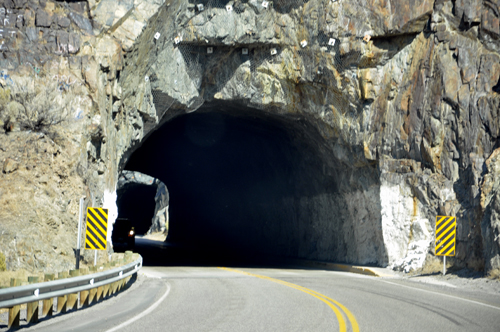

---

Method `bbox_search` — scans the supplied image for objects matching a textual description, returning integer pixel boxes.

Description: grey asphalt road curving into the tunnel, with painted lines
[21,241,500,332]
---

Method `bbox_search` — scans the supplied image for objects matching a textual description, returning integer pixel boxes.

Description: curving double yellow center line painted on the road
[219,267,359,332]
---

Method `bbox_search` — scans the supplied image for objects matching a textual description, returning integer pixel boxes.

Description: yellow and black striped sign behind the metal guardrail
[85,208,108,250]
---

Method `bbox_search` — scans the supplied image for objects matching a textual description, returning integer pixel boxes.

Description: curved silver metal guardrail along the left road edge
[0,256,142,326]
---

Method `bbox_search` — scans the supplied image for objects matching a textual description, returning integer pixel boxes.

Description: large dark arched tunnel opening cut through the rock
[125,103,383,263]
